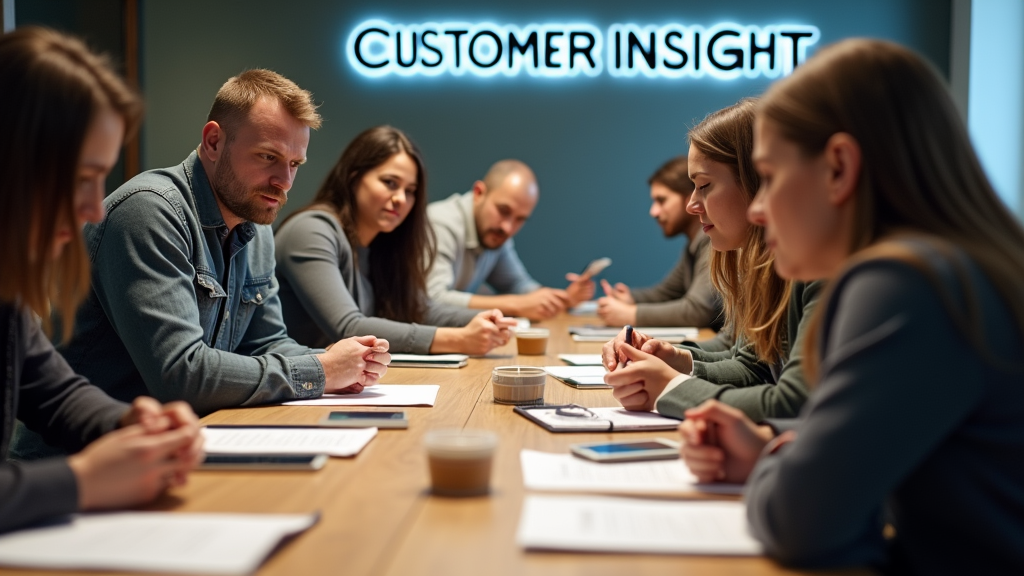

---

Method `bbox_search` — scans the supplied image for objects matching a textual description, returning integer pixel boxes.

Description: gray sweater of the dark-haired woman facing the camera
[274,210,478,354]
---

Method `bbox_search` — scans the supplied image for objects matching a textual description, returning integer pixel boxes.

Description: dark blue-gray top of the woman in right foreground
[746,250,1024,574]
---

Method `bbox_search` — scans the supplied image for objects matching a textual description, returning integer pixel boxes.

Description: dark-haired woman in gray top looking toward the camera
[274,126,514,355]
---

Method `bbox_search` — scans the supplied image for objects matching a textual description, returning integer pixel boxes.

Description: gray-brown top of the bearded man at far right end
[633,232,723,330]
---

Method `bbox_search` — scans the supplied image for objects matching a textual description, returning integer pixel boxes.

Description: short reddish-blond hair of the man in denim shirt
[206,69,321,134]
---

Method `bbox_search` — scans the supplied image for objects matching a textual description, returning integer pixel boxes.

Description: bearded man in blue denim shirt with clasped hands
[18,70,390,454]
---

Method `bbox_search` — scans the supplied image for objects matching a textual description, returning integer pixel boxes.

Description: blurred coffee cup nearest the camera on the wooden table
[423,429,498,496]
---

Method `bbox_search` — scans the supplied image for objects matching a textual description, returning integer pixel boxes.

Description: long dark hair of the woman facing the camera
[294,126,435,323]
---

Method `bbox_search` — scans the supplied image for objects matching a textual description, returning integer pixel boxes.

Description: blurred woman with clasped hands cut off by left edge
[0,28,203,531]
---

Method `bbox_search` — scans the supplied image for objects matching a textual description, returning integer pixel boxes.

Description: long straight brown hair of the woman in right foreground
[758,39,1024,380]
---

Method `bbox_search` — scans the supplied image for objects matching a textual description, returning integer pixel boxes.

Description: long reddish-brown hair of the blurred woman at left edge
[0,27,142,338]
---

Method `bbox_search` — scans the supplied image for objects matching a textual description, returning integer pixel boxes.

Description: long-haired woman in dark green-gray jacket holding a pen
[603,98,821,420]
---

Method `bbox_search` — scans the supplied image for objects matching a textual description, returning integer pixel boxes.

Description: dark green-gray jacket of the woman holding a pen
[657,282,823,421]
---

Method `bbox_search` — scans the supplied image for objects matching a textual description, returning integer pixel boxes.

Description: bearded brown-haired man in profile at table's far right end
[597,156,723,330]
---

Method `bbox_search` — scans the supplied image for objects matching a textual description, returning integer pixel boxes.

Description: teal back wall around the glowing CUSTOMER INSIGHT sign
[141,0,950,285]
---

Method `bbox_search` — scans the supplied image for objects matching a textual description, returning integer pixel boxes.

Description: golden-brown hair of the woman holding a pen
[689,98,793,363]
